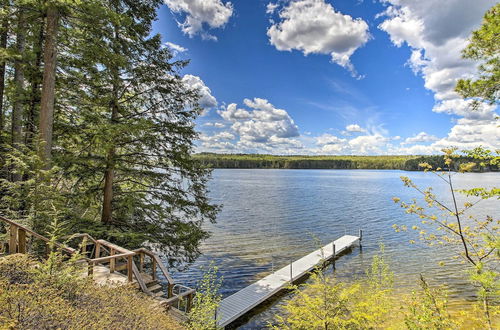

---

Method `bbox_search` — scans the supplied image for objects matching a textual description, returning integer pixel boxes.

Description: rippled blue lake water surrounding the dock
[170,169,500,329]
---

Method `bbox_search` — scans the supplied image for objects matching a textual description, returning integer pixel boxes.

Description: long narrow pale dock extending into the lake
[217,233,361,327]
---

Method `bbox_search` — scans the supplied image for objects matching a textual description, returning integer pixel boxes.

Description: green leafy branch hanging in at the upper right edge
[456,4,500,107]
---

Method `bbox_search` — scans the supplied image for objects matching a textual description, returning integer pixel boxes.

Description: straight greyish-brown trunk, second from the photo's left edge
[11,10,26,182]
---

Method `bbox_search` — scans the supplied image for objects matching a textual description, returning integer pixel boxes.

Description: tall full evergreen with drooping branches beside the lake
[58,0,217,259]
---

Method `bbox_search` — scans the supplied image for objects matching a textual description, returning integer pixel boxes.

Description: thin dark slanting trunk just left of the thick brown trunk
[26,17,45,149]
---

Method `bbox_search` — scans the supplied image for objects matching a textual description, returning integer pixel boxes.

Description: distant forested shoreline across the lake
[194,153,498,171]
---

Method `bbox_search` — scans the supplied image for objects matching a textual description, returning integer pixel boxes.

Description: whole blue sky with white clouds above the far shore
[154,0,500,154]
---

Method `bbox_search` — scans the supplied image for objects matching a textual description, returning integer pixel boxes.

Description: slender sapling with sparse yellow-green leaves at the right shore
[393,148,500,328]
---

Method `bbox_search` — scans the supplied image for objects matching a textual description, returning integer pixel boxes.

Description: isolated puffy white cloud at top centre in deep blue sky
[267,0,370,75]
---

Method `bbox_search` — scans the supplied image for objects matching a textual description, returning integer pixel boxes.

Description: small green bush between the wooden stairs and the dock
[186,265,222,330]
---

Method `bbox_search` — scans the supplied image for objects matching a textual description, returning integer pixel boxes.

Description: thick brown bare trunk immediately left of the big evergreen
[39,6,59,168]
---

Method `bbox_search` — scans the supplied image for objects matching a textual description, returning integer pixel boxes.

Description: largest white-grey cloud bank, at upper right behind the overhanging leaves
[378,0,495,120]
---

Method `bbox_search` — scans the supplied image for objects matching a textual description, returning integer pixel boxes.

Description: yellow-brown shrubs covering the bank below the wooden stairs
[0,255,181,329]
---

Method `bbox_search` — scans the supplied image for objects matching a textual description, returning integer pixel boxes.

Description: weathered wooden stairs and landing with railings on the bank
[0,216,195,317]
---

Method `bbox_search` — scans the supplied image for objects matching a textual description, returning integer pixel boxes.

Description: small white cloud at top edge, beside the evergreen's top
[164,0,233,40]
